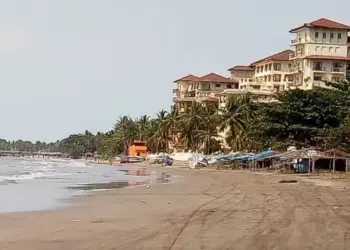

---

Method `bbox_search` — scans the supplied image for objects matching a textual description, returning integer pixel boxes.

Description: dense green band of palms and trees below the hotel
[0,82,350,157]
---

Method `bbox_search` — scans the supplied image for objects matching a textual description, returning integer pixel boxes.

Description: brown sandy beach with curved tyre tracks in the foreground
[0,168,350,250]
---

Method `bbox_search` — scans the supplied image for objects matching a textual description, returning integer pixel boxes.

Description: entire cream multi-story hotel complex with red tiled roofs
[173,18,350,114]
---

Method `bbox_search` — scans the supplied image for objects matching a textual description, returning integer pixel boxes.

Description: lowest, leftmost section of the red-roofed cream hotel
[173,73,238,112]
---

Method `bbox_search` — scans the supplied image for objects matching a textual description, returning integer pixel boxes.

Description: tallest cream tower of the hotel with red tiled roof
[289,18,350,89]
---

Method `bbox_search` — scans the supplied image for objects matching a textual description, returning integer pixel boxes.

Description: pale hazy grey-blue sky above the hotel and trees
[0,0,350,141]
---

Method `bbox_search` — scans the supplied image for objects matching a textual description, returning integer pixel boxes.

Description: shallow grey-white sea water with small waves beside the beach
[0,157,151,213]
